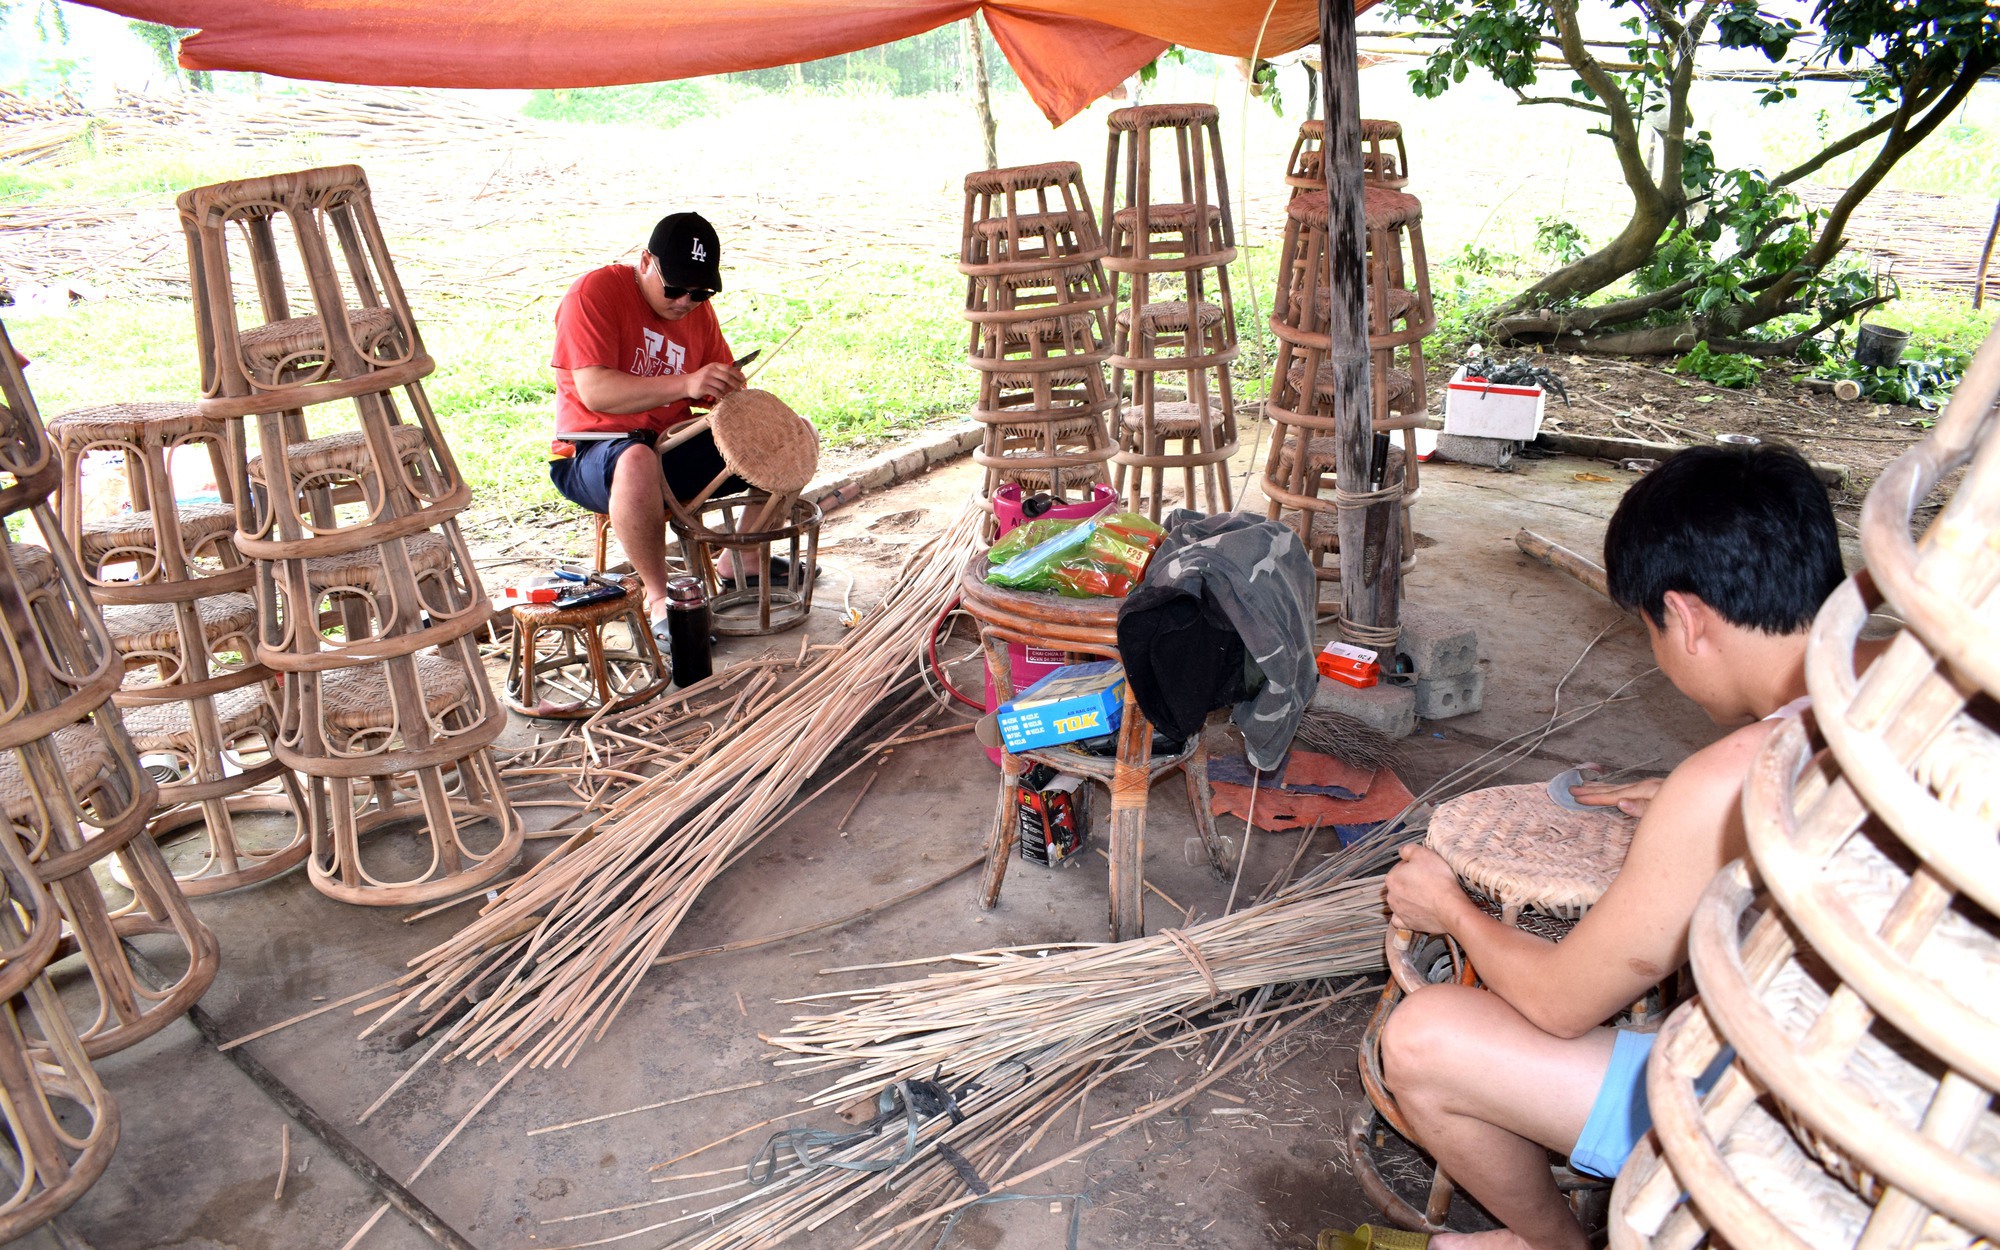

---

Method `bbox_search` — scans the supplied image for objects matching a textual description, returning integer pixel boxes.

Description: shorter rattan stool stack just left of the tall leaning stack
[48,402,306,894]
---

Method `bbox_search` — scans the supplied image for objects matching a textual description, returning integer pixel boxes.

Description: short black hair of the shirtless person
[1604,446,1846,634]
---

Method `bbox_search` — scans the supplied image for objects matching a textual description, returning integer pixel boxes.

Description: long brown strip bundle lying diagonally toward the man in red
[378,506,982,1066]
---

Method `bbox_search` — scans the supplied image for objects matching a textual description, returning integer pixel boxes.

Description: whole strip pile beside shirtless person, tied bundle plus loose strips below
[600,824,1412,1250]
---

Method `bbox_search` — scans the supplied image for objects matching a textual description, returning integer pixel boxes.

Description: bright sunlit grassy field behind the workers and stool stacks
[0,47,2000,514]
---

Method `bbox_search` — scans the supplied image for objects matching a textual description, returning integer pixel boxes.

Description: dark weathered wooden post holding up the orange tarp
[1300,0,1402,628]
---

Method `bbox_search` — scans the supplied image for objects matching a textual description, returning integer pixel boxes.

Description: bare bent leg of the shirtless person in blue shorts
[1382,986,1614,1250]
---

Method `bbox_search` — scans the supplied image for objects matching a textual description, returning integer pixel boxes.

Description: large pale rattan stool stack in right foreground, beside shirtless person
[1610,316,2000,1250]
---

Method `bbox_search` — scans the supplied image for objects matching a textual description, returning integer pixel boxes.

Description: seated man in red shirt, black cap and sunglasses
[548,212,752,628]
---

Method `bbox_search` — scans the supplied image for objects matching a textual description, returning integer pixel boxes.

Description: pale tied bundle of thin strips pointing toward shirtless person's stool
[764,826,1412,1104]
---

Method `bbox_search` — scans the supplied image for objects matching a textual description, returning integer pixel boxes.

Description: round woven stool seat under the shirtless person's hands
[1426,784,1638,922]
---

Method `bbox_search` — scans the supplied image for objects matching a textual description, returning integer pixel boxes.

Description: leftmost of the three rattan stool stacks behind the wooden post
[958,162,1116,508]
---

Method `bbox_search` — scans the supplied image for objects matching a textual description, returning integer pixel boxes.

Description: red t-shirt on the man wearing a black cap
[550,264,730,456]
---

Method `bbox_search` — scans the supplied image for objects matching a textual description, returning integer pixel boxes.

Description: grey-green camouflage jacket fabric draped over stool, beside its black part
[1144,508,1320,770]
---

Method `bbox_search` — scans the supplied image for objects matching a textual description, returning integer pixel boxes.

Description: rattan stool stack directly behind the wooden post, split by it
[1262,122,1438,604]
